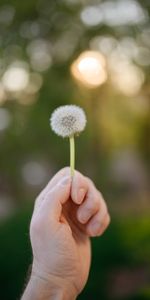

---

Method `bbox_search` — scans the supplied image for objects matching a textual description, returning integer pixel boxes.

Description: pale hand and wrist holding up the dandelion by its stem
[21,168,110,300]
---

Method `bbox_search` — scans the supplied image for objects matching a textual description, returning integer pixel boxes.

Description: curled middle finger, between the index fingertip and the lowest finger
[77,188,100,224]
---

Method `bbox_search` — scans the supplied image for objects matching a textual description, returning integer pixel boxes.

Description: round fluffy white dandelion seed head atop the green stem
[50,105,86,137]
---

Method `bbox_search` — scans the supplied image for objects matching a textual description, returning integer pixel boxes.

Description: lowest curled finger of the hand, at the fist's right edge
[86,212,110,237]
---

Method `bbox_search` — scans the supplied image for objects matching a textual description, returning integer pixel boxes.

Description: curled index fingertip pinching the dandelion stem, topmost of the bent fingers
[71,171,89,204]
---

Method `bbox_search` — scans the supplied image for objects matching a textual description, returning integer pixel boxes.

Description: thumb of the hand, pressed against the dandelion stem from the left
[40,176,71,222]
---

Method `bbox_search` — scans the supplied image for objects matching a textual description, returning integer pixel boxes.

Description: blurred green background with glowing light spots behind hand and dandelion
[0,0,150,300]
